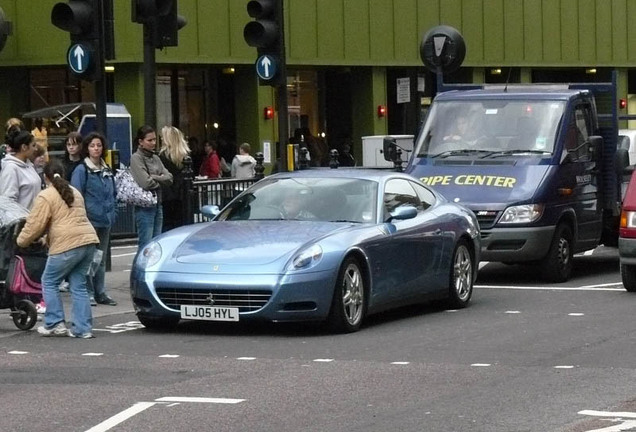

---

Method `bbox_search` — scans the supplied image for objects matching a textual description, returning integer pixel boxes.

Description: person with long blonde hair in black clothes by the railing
[159,126,190,232]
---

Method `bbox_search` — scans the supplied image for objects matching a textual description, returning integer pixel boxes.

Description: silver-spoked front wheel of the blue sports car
[327,257,367,333]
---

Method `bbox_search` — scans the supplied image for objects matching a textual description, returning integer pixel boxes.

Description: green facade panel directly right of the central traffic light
[286,0,318,61]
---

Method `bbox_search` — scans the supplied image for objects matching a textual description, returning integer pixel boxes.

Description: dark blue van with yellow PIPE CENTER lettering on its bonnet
[406,85,620,282]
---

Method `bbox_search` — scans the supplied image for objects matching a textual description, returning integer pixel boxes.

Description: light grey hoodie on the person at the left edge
[0,154,42,210]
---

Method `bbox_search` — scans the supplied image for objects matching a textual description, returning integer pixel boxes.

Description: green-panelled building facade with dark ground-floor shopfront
[0,0,636,165]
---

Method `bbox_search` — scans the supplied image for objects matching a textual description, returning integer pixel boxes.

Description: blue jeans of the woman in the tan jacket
[42,245,95,336]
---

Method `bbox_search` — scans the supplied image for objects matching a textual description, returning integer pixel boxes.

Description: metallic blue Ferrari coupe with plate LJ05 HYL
[130,169,480,332]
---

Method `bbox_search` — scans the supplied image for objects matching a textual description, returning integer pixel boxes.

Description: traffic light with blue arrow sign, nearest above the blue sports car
[243,0,285,86]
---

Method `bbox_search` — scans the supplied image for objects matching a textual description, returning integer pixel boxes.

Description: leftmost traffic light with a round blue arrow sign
[51,0,103,81]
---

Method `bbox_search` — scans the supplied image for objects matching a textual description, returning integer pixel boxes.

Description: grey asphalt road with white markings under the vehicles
[0,245,636,432]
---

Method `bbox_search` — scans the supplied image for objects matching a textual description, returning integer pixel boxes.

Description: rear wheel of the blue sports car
[448,240,475,309]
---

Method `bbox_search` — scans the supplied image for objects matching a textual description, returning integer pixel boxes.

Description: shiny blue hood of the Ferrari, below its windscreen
[173,221,349,267]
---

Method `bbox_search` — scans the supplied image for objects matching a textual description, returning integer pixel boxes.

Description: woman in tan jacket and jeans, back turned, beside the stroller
[17,159,99,339]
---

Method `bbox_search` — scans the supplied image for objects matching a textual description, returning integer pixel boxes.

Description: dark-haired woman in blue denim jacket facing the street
[71,132,117,306]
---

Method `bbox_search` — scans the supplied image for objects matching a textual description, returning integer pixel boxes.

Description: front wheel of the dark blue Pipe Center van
[540,224,574,282]
